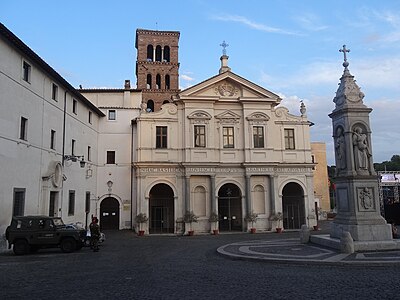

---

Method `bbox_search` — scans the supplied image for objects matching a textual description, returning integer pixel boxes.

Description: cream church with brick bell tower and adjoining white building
[0,24,316,234]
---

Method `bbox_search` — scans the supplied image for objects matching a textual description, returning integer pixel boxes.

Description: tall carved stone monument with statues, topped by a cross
[312,45,400,251]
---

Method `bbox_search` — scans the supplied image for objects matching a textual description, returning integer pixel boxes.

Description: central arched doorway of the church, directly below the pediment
[218,183,243,231]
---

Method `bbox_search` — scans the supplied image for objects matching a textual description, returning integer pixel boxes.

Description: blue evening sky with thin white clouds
[0,0,400,165]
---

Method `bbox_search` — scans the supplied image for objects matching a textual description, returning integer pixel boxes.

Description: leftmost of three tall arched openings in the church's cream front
[149,183,175,233]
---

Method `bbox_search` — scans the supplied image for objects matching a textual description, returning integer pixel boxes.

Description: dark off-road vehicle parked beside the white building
[6,216,86,255]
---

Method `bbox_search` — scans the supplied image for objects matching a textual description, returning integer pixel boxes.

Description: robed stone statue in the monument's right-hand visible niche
[353,127,372,171]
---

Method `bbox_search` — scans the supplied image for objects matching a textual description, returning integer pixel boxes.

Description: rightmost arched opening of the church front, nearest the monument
[282,182,306,229]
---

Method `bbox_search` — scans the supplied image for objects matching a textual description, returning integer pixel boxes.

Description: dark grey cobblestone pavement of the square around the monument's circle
[0,221,400,300]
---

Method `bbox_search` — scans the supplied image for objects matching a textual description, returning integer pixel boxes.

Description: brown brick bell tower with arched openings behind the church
[135,29,180,111]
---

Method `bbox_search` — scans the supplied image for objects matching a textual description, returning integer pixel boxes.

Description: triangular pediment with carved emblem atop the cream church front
[177,71,281,105]
